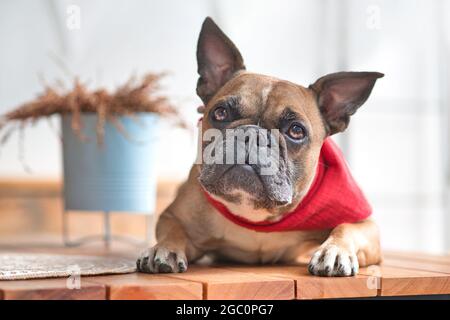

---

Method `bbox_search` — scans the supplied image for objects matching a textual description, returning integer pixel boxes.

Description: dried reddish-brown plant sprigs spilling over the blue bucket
[0,73,186,145]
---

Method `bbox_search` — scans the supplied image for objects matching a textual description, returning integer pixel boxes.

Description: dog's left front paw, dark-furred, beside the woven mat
[136,245,187,273]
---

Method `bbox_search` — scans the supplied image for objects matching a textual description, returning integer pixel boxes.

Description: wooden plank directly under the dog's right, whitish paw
[218,266,377,299]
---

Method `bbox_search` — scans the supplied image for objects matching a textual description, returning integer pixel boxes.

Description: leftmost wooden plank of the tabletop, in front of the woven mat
[0,278,106,300]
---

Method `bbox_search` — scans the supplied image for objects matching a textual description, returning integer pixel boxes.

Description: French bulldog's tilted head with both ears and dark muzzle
[197,18,383,221]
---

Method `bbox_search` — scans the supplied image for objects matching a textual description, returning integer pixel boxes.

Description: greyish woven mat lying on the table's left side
[0,253,136,280]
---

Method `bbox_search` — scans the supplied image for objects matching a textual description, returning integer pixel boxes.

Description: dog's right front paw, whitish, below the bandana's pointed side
[308,244,359,277]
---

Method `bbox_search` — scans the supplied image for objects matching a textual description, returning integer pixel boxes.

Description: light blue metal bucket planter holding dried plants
[62,113,159,214]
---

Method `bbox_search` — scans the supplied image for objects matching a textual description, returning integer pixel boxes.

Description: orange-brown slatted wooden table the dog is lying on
[0,247,450,300]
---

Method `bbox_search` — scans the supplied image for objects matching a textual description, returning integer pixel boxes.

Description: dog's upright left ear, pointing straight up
[197,17,245,105]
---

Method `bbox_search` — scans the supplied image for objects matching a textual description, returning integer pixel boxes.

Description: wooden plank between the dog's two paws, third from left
[163,265,295,300]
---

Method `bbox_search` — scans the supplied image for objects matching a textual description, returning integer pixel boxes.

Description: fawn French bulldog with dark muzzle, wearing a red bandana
[137,17,383,276]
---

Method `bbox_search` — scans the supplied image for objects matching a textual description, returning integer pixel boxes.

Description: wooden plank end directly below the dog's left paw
[88,273,203,300]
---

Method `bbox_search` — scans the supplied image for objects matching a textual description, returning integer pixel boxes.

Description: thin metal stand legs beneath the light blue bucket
[63,210,153,249]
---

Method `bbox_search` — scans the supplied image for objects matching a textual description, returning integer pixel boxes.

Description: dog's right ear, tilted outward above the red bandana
[309,72,384,135]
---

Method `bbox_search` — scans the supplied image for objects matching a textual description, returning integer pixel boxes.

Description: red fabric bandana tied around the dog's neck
[205,138,372,232]
